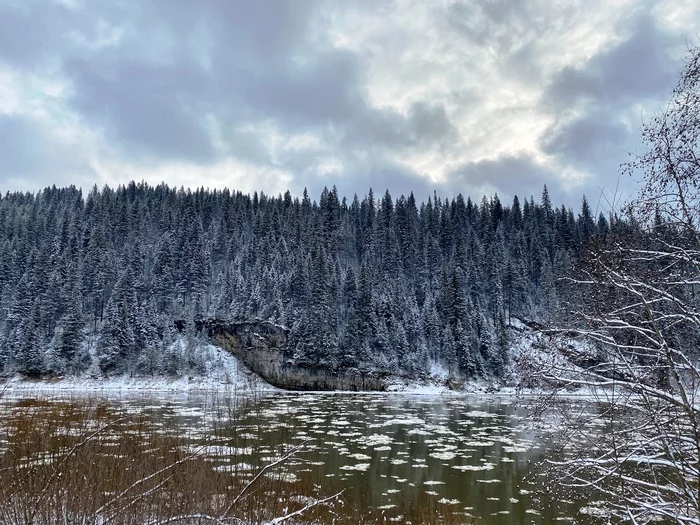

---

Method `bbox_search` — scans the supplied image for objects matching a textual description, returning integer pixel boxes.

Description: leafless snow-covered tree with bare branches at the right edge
[548,42,700,523]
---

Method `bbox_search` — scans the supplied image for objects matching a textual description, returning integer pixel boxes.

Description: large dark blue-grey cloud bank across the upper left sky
[0,0,459,194]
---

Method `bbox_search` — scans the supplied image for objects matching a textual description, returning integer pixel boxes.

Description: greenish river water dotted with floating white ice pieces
[0,393,600,524]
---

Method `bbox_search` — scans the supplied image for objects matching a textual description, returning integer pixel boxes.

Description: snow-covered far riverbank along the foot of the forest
[0,320,580,395]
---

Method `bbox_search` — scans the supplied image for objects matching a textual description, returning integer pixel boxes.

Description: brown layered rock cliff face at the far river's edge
[198,320,386,391]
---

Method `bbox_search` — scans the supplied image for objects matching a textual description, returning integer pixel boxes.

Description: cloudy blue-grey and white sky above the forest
[0,0,700,209]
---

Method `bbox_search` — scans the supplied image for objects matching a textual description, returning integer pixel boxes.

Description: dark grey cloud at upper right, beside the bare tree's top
[541,15,678,200]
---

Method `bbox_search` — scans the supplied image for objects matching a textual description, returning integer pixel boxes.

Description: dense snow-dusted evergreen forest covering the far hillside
[0,182,616,377]
